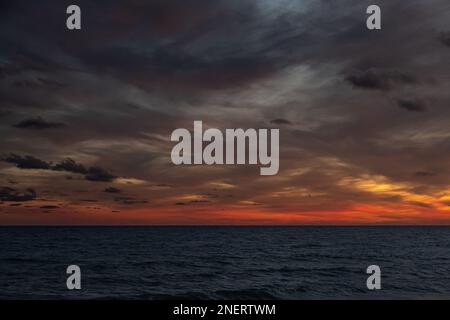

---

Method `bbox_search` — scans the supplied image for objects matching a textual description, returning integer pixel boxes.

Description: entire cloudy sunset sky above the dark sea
[0,0,450,225]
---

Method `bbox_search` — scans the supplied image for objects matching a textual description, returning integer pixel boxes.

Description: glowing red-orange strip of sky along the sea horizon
[1,204,450,225]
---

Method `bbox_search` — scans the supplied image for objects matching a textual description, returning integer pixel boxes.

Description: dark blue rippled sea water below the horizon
[0,227,450,299]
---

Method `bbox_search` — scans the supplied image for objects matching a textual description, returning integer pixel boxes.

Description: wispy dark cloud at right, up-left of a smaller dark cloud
[345,69,416,90]
